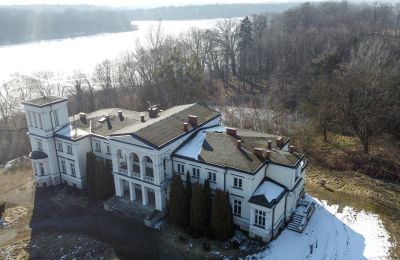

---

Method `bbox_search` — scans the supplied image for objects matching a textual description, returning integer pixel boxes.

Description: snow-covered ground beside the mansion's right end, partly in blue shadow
[253,197,393,260]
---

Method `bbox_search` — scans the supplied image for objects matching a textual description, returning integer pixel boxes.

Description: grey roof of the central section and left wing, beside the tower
[70,104,220,147]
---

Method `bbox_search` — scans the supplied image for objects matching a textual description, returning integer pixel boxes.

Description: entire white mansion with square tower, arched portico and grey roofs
[23,96,307,244]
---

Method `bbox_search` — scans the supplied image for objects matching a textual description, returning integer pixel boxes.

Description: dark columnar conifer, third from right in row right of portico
[190,183,205,232]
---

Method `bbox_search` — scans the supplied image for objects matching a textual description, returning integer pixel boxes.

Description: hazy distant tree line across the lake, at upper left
[0,6,134,45]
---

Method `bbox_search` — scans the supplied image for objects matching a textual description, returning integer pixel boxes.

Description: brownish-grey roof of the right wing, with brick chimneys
[198,129,302,173]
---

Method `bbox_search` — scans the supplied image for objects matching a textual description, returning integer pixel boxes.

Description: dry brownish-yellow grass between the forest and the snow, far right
[305,165,400,259]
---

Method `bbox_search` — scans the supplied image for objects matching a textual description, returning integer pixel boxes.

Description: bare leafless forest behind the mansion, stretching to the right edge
[0,1,400,179]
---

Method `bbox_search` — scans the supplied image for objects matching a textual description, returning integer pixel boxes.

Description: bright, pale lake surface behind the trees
[0,19,231,82]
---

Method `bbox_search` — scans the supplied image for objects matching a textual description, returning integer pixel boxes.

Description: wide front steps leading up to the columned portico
[111,198,154,222]
